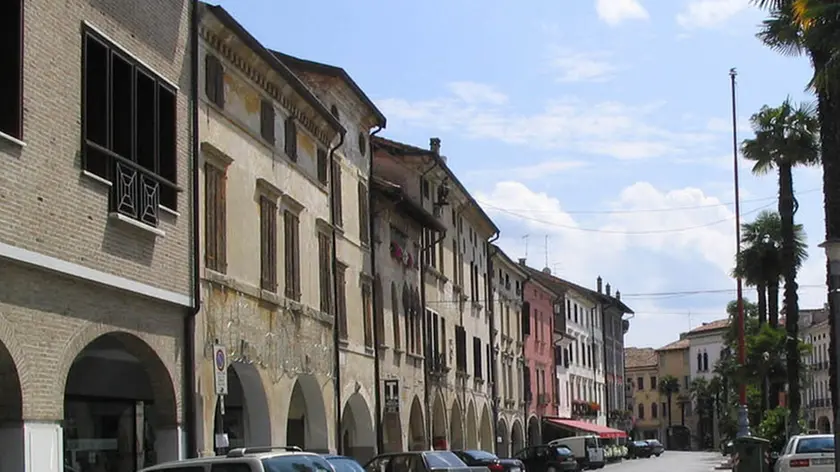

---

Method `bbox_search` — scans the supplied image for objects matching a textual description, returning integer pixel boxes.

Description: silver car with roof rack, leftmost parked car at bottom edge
[140,446,334,472]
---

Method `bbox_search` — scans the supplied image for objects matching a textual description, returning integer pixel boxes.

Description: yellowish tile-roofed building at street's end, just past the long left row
[624,347,662,439]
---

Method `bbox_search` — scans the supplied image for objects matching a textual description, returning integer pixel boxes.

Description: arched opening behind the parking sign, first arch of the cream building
[213,362,271,451]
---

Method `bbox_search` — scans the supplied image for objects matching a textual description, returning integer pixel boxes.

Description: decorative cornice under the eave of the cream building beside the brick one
[199,24,332,144]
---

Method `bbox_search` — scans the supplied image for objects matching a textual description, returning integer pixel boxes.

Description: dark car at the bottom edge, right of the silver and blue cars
[364,451,490,472]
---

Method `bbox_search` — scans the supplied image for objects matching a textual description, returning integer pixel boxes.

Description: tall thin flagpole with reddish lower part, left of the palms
[729,67,750,438]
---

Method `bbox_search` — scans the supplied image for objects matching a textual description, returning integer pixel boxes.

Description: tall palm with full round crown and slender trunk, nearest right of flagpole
[741,99,820,434]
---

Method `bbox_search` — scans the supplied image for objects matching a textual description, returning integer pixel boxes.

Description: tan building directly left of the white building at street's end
[656,339,695,449]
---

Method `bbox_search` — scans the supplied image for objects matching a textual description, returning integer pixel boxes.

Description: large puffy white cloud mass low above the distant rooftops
[476,181,752,347]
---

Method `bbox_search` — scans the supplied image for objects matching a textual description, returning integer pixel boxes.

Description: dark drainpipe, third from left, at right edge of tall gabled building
[367,126,385,454]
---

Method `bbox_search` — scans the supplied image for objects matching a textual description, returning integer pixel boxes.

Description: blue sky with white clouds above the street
[213,0,826,347]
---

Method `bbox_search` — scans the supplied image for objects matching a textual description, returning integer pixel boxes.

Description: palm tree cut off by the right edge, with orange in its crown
[753,0,840,438]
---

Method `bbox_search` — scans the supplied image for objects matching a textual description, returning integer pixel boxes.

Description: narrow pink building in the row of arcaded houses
[522,279,557,445]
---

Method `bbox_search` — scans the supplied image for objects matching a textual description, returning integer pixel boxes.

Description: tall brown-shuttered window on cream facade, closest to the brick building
[204,164,227,273]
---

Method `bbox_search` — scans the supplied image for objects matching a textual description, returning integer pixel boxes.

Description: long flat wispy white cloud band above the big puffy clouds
[377,86,713,159]
